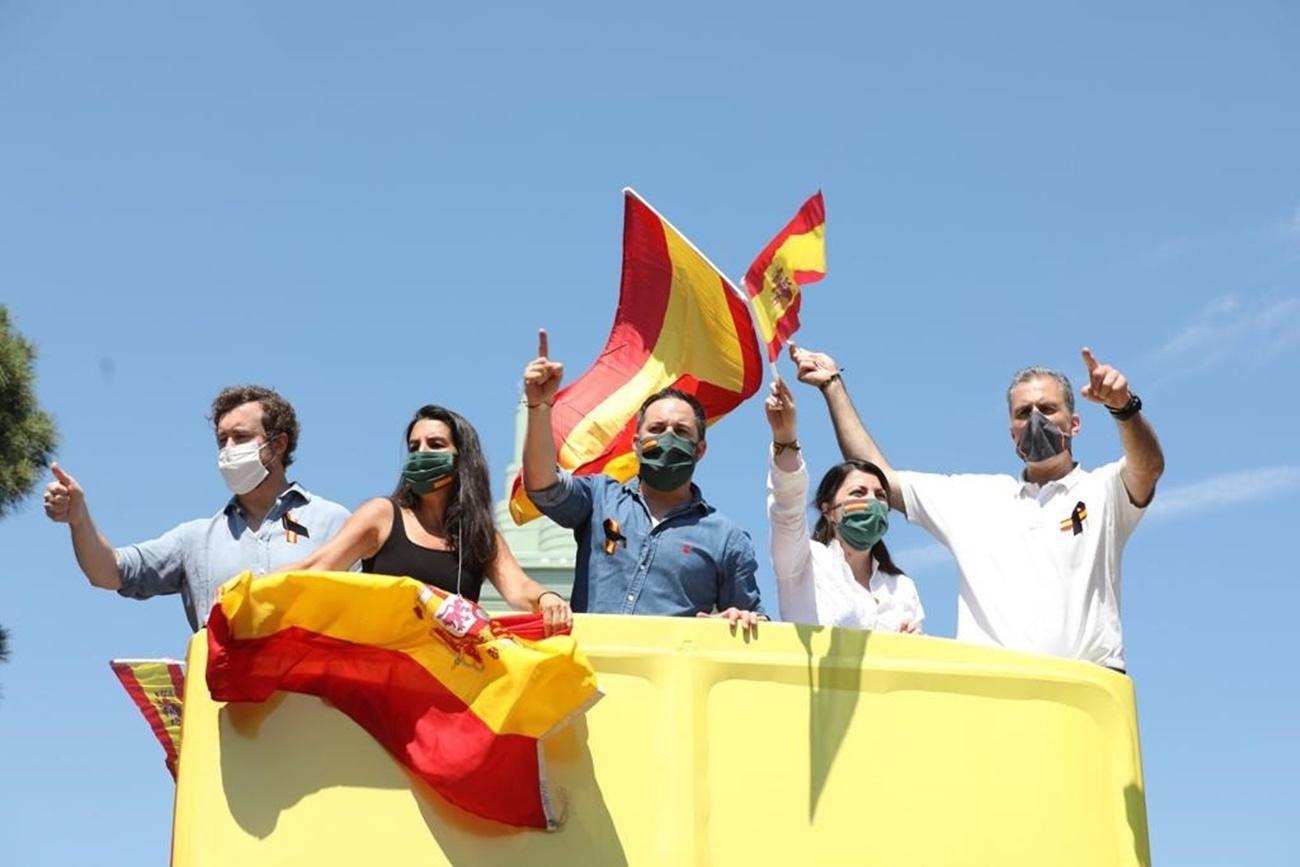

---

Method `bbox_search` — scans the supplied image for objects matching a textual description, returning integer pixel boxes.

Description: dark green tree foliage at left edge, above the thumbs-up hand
[0,304,57,517]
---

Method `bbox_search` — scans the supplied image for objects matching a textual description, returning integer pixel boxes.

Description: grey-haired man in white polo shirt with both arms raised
[790,346,1165,671]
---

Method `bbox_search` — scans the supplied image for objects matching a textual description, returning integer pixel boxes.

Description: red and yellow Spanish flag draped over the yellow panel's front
[207,572,599,828]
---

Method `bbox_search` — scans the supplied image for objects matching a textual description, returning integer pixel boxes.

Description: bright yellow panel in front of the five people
[173,616,1149,867]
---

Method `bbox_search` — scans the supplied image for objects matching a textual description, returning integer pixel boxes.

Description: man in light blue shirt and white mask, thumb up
[46,386,348,630]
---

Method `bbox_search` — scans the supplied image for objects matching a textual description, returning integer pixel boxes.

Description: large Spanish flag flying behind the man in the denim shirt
[510,188,763,524]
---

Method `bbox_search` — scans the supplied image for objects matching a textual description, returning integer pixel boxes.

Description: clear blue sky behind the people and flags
[0,1,1300,864]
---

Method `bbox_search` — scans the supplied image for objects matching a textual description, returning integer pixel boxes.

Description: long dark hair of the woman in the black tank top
[391,403,497,576]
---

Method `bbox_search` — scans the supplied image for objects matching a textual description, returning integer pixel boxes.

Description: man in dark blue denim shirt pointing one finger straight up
[524,331,767,628]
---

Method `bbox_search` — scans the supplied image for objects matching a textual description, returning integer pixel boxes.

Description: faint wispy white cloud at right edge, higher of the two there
[1151,292,1300,372]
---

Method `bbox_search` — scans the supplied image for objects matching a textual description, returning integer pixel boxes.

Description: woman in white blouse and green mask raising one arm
[766,380,926,633]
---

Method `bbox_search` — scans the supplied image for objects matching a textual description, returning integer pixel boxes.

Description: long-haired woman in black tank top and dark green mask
[289,404,572,633]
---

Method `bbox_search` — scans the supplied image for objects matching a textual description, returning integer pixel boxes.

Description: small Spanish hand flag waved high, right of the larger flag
[745,191,826,361]
